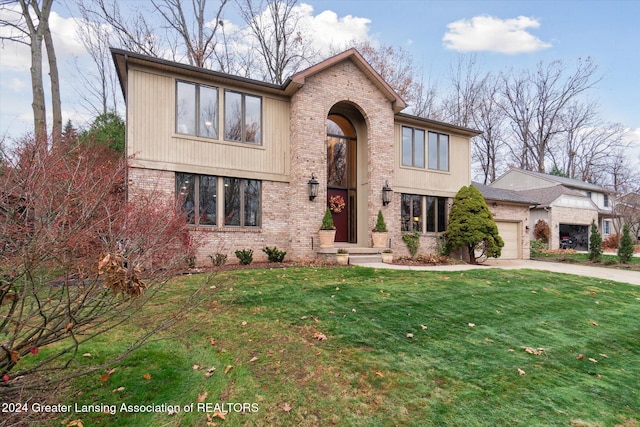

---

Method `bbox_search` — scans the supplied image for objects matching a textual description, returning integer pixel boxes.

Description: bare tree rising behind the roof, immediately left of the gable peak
[237,0,318,84]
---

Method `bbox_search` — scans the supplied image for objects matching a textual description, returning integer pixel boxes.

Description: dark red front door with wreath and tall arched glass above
[327,114,357,243]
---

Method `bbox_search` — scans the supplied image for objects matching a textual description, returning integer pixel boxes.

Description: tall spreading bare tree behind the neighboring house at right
[502,58,600,172]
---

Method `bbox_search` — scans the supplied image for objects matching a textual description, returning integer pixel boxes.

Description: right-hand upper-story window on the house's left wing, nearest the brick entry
[224,90,262,144]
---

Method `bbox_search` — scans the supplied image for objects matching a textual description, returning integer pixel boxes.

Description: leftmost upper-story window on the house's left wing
[176,81,218,138]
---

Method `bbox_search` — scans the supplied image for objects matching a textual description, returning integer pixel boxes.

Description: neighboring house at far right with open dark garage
[491,168,614,250]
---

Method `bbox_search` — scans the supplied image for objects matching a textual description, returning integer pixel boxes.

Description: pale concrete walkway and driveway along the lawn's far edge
[352,259,640,285]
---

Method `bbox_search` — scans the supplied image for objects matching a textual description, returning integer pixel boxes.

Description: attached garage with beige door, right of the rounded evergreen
[472,182,538,259]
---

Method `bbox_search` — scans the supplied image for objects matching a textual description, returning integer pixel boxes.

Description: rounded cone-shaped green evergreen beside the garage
[445,185,504,264]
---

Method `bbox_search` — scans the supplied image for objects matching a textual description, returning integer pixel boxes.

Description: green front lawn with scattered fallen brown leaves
[20,267,640,426]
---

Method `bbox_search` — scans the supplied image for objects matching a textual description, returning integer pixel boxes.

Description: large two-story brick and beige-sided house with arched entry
[112,49,479,263]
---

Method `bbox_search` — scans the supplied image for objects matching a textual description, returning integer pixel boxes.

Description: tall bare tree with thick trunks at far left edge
[0,0,62,143]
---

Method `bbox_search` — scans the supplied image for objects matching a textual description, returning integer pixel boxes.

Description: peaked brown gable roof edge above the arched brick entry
[283,48,407,113]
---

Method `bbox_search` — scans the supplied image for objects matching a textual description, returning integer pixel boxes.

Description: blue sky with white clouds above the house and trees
[0,0,640,162]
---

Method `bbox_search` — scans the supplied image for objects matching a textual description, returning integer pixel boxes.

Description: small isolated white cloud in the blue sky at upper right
[442,15,551,54]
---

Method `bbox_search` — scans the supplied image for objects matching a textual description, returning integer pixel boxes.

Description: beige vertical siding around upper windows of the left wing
[127,70,290,181]
